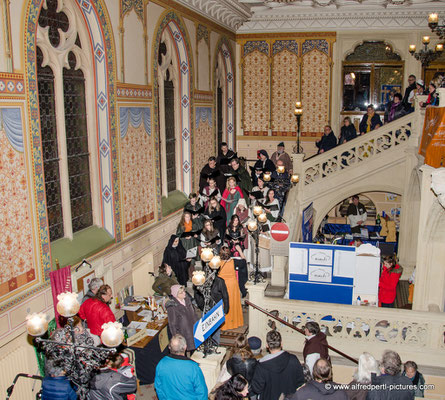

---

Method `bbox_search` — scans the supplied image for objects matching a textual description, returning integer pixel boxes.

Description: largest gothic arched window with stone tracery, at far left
[37,0,98,241]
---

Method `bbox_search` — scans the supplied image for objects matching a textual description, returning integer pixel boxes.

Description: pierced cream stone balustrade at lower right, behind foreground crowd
[249,285,445,366]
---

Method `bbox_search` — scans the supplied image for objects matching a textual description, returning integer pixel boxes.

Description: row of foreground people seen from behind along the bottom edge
[151,328,425,400]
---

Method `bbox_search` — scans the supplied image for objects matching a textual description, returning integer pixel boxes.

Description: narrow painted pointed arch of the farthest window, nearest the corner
[213,36,236,149]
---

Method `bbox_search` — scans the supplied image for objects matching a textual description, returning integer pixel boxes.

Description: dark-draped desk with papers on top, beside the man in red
[124,304,170,385]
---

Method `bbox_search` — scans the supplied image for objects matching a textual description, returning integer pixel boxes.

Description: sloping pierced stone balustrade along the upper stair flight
[302,113,419,186]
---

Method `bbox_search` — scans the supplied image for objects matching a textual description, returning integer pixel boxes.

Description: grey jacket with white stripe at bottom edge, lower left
[88,369,137,400]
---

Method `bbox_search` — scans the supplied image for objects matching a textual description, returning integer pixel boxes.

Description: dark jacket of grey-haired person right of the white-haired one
[366,374,414,400]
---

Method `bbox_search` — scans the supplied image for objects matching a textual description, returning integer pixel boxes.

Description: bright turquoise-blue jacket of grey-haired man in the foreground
[155,354,208,400]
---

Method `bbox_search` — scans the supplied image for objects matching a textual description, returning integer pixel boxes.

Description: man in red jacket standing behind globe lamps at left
[78,285,116,337]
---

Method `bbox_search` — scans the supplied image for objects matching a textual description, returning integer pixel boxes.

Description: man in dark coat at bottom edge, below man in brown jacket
[288,358,348,400]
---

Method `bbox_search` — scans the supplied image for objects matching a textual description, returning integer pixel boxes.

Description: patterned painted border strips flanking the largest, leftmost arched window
[22,0,121,300]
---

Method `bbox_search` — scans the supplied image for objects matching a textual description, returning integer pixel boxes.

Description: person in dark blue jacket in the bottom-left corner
[42,358,77,400]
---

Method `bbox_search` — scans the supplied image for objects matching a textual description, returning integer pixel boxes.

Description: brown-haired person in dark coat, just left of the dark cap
[226,334,258,384]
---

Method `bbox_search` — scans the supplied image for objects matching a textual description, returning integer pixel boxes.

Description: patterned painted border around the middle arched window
[151,10,194,220]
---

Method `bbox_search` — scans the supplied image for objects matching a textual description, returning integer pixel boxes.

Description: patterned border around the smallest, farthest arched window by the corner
[213,36,236,151]
